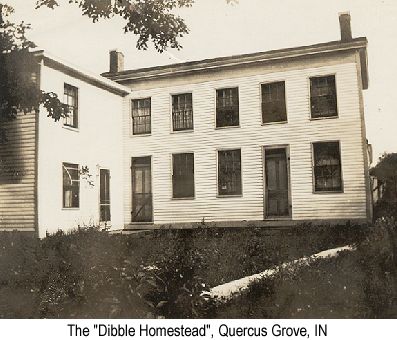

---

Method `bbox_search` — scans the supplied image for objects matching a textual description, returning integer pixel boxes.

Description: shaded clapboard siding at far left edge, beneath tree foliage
[0,112,36,232]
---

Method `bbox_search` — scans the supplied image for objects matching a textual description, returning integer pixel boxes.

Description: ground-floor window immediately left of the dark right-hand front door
[218,149,242,196]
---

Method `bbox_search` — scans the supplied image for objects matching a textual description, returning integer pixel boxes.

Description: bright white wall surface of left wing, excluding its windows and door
[38,66,123,237]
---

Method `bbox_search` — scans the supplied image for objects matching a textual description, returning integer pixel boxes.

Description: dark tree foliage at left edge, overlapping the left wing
[0,3,68,143]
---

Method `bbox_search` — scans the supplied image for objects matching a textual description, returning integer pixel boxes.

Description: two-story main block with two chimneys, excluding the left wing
[104,13,371,228]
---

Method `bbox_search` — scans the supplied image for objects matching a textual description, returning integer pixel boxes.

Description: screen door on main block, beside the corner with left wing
[131,157,153,222]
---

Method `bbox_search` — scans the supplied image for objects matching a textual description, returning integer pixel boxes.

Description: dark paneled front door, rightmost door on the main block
[265,147,291,218]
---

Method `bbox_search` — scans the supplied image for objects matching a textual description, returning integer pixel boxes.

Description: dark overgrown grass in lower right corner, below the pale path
[215,218,397,318]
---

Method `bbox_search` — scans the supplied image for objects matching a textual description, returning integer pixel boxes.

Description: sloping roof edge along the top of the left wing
[33,50,131,96]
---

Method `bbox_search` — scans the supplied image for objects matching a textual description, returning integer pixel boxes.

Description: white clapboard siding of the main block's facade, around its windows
[123,52,366,224]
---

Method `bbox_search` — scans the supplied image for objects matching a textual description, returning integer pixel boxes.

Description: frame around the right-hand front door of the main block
[262,144,292,220]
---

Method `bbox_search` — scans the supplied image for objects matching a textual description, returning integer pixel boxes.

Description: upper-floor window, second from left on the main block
[172,93,193,131]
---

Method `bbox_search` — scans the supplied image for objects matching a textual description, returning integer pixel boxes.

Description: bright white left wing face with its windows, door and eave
[38,56,128,236]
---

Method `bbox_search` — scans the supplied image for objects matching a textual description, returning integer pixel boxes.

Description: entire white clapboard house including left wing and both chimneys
[0,13,372,236]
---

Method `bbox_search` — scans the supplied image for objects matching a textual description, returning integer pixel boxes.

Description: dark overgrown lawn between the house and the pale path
[0,220,380,318]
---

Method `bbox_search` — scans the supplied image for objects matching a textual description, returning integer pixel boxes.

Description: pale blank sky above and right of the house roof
[3,0,397,164]
